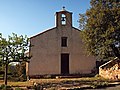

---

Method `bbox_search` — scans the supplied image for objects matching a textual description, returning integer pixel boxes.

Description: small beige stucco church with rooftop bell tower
[26,7,96,77]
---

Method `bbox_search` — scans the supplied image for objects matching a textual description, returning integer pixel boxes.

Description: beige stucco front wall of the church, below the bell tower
[28,26,96,75]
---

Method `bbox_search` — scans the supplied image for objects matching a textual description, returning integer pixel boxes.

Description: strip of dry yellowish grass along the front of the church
[0,77,116,87]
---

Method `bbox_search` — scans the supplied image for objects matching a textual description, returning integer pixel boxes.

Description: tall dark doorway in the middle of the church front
[61,53,69,75]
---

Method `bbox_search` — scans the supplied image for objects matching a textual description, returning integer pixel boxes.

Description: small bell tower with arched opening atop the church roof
[56,7,72,27]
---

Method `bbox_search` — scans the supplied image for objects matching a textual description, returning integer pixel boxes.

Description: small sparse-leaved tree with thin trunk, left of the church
[0,33,30,85]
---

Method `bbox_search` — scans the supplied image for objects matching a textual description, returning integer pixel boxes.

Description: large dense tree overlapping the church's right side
[79,0,120,60]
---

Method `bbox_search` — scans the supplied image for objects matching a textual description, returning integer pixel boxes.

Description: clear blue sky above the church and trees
[0,0,90,38]
